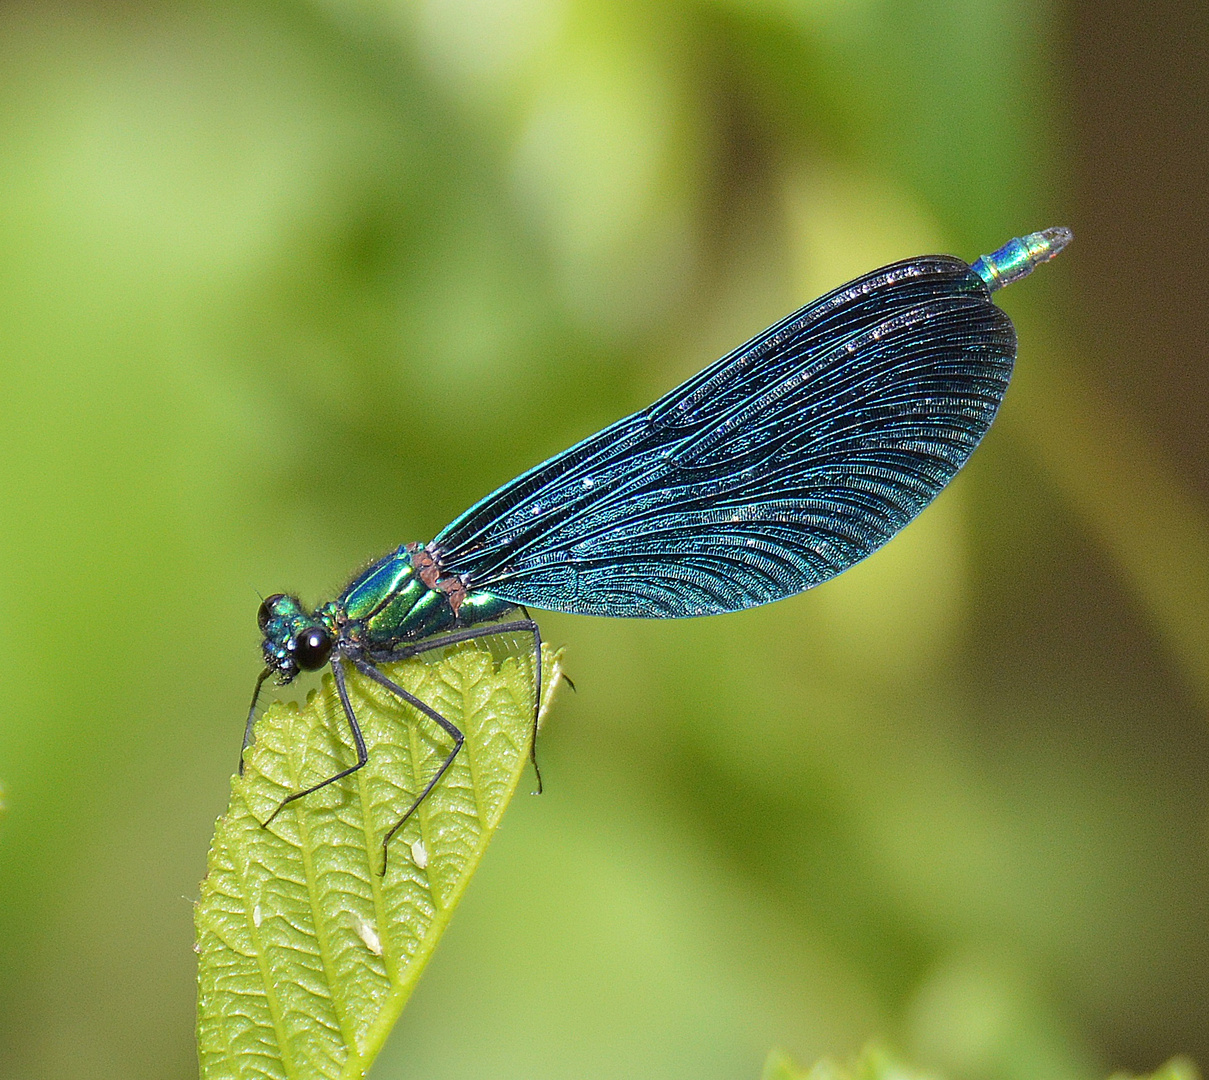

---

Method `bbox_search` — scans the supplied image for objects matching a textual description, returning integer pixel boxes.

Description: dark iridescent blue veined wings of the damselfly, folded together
[433,255,1016,617]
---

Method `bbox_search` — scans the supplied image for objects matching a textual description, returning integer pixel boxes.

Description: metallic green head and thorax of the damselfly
[262,544,515,682]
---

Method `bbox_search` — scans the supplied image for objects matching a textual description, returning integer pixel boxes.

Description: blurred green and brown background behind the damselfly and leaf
[0,0,1209,1080]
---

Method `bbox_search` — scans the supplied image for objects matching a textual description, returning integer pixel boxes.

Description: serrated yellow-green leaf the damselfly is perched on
[195,641,561,1080]
